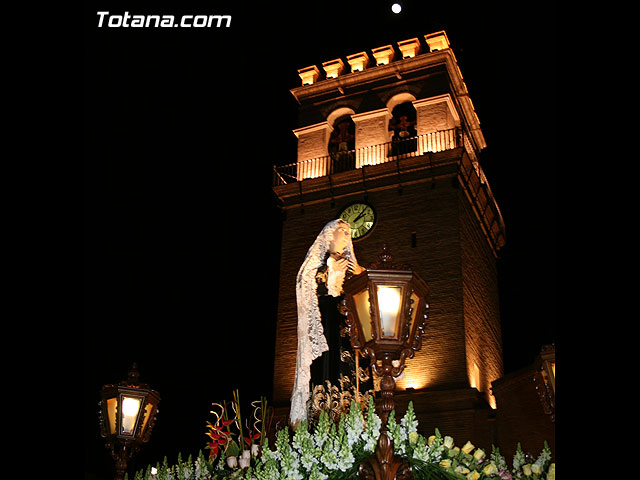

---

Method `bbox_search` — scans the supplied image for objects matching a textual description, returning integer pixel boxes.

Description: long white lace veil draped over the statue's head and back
[289,219,357,425]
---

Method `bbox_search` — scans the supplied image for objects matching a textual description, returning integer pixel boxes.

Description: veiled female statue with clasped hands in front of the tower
[289,219,364,426]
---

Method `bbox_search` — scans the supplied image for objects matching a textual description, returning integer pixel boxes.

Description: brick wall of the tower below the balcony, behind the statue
[273,174,502,403]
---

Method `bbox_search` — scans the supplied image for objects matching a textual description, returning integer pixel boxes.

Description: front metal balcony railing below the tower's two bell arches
[273,128,463,186]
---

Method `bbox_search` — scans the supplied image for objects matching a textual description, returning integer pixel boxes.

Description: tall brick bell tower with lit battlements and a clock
[273,31,505,444]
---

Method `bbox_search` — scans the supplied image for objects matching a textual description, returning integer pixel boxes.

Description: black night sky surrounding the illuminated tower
[83,0,556,479]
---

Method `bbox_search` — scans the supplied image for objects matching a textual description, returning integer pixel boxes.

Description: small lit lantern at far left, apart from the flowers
[98,363,160,480]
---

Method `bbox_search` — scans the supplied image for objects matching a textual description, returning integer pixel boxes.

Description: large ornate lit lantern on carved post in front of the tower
[342,245,429,480]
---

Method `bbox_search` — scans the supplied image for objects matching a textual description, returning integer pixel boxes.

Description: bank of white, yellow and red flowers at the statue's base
[134,391,555,480]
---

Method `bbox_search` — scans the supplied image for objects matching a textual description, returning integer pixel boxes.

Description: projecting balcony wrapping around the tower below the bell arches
[273,127,505,256]
